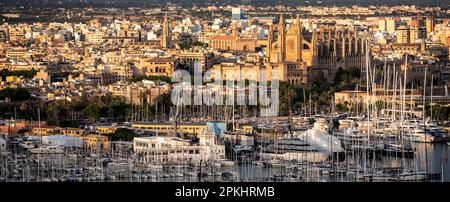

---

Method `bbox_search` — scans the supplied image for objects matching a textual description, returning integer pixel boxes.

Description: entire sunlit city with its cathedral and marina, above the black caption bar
[0,0,450,182]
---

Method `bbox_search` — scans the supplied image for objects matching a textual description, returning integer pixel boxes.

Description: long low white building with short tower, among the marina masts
[133,134,225,163]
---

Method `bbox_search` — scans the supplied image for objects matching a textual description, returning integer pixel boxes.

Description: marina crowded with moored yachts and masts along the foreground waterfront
[0,118,450,182]
